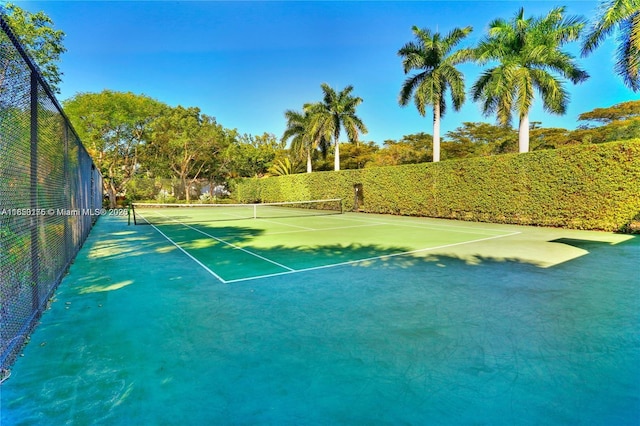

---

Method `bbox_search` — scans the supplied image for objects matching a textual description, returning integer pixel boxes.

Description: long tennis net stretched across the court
[131,198,343,225]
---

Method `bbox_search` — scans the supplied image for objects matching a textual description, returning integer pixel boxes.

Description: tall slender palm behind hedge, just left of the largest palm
[398,26,473,161]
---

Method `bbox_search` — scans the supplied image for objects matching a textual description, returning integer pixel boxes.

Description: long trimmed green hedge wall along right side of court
[234,139,640,231]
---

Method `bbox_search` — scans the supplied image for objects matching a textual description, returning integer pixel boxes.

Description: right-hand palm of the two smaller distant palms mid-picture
[305,83,367,170]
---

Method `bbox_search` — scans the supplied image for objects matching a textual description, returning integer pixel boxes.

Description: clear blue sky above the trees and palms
[15,0,640,144]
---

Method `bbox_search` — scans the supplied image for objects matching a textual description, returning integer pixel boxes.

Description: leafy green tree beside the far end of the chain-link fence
[64,90,168,207]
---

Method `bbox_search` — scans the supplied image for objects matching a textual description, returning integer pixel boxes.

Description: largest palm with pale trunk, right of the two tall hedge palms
[471,7,589,152]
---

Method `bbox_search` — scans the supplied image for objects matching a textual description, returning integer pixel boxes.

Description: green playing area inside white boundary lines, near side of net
[132,207,519,283]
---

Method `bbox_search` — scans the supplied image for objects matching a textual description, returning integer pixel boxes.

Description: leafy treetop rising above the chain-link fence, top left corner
[0,3,66,93]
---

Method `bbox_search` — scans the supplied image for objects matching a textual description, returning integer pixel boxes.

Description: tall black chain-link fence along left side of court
[0,11,102,374]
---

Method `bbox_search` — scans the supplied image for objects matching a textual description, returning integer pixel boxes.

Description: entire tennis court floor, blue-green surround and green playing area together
[0,212,640,426]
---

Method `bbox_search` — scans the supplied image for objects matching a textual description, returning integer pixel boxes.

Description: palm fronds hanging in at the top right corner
[582,0,640,92]
